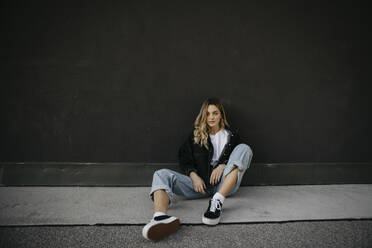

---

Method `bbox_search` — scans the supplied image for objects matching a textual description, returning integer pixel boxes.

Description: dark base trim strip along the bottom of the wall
[0,162,372,187]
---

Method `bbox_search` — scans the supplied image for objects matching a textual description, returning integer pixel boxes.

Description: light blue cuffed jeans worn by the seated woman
[149,144,253,205]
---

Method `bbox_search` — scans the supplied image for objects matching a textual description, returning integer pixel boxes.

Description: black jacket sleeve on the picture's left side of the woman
[178,135,198,176]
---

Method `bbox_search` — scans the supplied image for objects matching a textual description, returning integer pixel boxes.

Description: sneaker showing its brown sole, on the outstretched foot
[142,215,180,241]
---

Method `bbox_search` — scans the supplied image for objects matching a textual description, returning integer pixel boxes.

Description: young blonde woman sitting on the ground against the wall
[142,98,252,240]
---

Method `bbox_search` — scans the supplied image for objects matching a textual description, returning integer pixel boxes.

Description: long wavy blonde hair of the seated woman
[194,98,229,149]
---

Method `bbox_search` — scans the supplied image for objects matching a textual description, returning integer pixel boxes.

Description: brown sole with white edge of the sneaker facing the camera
[143,219,181,241]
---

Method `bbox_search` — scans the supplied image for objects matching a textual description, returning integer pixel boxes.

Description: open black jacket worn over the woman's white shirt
[178,127,242,188]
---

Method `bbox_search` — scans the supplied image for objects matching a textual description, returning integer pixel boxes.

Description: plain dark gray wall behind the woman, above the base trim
[0,0,372,163]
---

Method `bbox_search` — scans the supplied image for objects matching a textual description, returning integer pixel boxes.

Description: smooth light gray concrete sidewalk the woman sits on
[0,184,372,226]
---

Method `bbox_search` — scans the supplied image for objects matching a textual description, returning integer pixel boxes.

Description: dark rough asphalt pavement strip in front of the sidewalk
[0,220,372,248]
